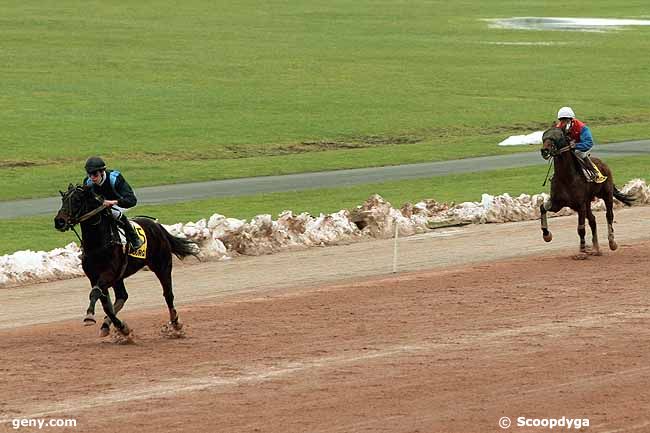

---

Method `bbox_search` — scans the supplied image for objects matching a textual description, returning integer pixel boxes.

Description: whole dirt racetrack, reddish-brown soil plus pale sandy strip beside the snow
[0,208,650,433]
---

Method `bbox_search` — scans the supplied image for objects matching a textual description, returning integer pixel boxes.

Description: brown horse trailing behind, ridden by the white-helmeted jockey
[540,128,634,255]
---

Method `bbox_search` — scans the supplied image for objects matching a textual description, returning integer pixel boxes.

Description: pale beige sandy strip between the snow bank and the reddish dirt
[0,207,650,330]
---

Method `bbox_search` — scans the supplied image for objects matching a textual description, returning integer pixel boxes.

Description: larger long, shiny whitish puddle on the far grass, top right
[484,17,650,32]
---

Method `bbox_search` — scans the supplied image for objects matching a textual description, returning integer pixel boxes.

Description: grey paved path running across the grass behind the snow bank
[0,140,650,219]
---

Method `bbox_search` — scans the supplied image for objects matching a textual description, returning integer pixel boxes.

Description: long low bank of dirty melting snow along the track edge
[0,179,650,287]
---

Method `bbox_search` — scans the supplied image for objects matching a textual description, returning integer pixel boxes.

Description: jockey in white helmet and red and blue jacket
[555,107,607,183]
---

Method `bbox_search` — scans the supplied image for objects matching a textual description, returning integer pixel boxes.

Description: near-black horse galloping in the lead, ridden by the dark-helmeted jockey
[54,184,199,337]
